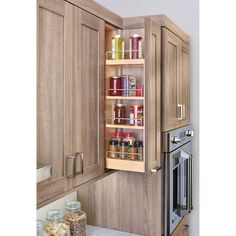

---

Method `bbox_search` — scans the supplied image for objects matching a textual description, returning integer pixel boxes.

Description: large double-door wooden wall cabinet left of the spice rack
[37,0,104,203]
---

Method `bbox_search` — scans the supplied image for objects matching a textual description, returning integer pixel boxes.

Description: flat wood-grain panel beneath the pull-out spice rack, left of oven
[78,171,161,236]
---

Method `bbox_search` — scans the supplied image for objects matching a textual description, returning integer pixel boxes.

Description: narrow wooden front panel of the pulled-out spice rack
[145,18,161,174]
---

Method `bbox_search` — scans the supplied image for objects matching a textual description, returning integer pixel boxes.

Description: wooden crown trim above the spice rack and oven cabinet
[123,15,189,44]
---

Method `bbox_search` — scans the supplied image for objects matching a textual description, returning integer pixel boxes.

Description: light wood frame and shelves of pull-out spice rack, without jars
[105,24,145,173]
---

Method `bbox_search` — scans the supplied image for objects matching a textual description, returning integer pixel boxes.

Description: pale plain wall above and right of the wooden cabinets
[96,0,199,236]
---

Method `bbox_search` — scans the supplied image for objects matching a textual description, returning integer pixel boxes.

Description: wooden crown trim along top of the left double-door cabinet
[67,0,123,28]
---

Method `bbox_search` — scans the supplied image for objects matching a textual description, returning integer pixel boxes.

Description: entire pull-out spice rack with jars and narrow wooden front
[104,18,161,174]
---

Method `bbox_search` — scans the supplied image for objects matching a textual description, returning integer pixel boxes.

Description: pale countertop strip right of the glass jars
[87,225,142,236]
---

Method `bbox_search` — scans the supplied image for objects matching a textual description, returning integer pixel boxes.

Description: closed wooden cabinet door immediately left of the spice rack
[73,7,105,186]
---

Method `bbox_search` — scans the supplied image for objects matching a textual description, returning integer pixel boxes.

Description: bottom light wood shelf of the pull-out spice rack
[106,158,145,173]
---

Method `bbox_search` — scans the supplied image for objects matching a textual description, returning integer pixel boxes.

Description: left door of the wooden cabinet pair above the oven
[162,28,181,131]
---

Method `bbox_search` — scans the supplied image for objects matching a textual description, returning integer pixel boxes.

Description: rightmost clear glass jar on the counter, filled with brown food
[65,200,87,236]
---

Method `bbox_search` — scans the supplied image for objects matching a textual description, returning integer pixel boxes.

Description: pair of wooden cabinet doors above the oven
[162,27,190,131]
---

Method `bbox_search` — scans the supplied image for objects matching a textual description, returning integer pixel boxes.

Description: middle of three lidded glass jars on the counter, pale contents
[45,209,70,236]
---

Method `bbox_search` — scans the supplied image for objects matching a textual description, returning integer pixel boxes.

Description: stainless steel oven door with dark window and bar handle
[165,142,192,235]
